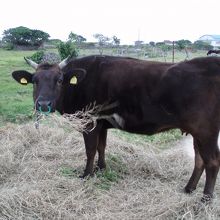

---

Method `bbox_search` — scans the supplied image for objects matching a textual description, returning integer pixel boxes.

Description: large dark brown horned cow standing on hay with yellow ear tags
[12,56,220,201]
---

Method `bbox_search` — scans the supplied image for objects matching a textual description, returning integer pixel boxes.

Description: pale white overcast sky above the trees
[0,0,220,44]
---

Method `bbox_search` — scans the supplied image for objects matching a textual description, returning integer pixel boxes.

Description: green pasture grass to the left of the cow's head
[0,49,36,125]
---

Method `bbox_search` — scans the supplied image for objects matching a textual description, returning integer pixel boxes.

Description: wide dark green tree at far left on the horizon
[2,26,50,47]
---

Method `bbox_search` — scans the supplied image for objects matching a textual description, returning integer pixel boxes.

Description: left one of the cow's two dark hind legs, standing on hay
[185,138,204,193]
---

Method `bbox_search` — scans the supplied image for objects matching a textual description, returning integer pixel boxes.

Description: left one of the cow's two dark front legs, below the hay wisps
[81,125,100,178]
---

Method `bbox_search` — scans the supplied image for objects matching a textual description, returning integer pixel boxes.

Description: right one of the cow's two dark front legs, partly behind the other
[97,129,107,169]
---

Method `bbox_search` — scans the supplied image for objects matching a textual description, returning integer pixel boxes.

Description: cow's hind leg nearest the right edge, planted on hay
[198,132,220,201]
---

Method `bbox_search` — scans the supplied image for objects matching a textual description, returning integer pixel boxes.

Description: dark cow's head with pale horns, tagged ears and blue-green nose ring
[12,58,86,113]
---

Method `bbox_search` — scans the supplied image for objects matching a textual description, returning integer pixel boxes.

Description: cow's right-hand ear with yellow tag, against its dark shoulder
[64,68,86,85]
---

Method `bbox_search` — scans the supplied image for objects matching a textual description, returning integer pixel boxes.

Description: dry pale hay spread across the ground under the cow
[0,119,220,220]
